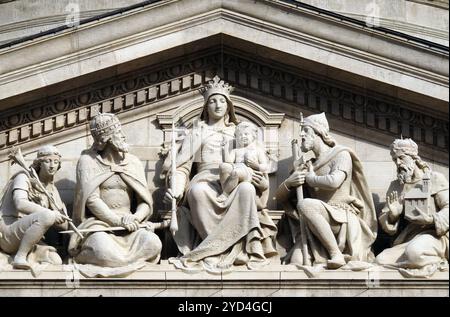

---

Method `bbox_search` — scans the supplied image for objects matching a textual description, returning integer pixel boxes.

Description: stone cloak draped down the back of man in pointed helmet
[277,146,377,264]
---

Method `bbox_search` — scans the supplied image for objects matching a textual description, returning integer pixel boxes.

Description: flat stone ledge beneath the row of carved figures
[0,261,449,297]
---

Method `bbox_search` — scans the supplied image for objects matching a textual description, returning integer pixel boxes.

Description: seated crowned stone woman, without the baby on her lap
[165,76,277,272]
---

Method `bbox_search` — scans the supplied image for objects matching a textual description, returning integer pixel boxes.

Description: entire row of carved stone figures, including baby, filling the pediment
[0,76,449,276]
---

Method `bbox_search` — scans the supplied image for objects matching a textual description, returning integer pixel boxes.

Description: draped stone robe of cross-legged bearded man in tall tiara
[69,149,162,274]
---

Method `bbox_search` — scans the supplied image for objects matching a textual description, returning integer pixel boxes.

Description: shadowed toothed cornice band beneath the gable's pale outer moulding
[0,47,448,162]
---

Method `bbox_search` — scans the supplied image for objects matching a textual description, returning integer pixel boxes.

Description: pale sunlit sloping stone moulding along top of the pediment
[0,0,448,100]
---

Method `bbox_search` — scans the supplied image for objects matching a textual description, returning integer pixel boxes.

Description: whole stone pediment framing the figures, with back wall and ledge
[0,0,449,296]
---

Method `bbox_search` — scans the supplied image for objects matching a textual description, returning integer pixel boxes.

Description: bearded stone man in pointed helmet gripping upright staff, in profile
[277,113,377,269]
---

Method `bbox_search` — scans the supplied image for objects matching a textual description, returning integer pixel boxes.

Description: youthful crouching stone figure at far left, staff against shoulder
[0,145,70,269]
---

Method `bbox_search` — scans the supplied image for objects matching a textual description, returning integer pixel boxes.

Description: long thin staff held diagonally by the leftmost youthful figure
[8,147,84,239]
